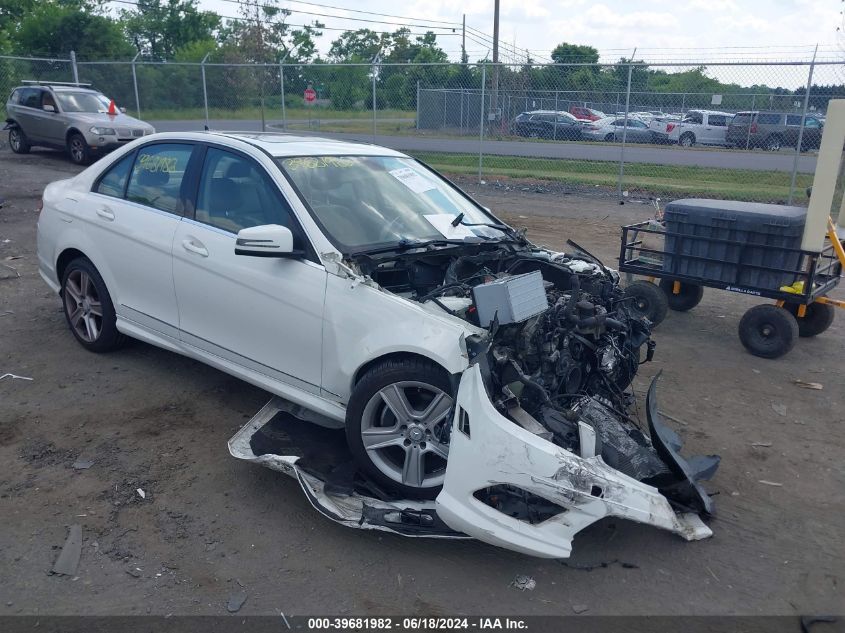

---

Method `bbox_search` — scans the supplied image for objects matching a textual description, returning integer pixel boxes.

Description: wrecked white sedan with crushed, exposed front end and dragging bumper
[38,133,718,557]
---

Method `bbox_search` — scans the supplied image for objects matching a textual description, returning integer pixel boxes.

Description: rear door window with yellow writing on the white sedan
[126,143,194,213]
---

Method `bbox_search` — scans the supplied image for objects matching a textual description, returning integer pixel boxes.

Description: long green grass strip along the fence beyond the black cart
[411,152,813,202]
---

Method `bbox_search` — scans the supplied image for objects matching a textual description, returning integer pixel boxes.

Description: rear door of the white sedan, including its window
[84,142,196,339]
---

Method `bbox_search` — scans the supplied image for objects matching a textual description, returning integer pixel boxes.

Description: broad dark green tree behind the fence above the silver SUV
[12,2,132,60]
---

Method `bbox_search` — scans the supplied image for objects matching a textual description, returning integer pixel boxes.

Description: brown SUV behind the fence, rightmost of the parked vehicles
[727,111,824,152]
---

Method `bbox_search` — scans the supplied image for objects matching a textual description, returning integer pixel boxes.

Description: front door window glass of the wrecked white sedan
[196,147,297,235]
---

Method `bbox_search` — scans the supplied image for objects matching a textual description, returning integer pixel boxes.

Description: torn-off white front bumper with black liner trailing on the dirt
[229,364,718,558]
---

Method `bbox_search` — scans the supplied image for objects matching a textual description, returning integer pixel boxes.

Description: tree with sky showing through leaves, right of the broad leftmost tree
[120,0,220,59]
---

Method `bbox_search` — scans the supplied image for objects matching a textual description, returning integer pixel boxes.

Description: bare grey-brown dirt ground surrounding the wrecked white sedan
[0,146,845,615]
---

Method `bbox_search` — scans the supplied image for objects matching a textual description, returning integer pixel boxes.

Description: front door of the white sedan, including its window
[173,147,326,393]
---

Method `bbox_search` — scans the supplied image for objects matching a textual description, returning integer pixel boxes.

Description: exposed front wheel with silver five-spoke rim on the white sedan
[346,358,454,499]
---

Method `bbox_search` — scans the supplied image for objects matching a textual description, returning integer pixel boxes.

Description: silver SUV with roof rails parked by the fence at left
[4,82,155,165]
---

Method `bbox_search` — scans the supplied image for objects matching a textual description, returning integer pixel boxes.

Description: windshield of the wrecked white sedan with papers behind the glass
[276,156,504,251]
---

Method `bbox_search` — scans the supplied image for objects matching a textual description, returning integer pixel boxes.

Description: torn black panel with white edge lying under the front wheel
[229,398,468,538]
